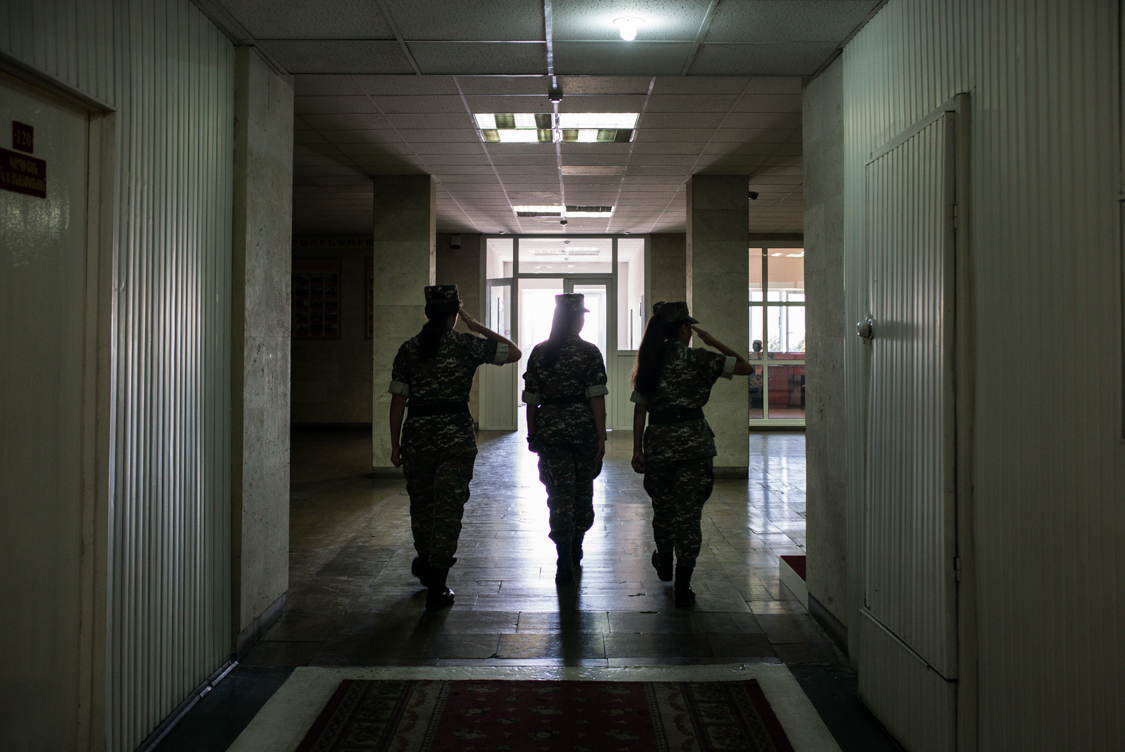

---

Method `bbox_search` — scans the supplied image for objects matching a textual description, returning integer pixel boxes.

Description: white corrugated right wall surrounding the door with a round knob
[844,0,1125,751]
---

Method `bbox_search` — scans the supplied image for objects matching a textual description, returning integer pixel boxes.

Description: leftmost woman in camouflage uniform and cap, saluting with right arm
[389,285,520,611]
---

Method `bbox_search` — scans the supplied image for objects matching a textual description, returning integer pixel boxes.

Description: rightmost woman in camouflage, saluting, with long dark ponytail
[630,302,753,607]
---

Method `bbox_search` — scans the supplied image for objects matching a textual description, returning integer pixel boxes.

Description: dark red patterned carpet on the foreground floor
[297,679,793,752]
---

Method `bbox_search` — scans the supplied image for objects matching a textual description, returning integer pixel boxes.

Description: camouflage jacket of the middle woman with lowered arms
[523,333,610,446]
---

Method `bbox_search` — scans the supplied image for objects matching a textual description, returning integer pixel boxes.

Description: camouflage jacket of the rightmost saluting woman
[629,340,735,463]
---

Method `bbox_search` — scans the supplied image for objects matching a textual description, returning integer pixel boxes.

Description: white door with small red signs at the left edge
[0,74,90,750]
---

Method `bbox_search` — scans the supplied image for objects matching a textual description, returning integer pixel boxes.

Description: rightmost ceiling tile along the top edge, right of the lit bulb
[704,0,879,44]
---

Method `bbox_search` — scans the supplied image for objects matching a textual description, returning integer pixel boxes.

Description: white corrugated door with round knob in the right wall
[860,113,957,752]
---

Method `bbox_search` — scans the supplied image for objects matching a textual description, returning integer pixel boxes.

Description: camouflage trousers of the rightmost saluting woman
[645,457,714,564]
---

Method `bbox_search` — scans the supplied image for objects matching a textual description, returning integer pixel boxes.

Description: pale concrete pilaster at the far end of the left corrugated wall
[231,47,294,659]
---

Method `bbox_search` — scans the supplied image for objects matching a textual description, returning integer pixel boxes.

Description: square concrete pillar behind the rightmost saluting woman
[687,174,750,477]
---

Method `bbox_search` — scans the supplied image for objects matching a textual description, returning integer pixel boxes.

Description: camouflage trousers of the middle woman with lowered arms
[538,445,596,544]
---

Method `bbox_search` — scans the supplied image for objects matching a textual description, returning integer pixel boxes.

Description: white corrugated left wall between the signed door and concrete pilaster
[0,0,234,751]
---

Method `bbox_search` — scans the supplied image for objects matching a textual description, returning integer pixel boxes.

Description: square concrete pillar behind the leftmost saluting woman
[371,174,438,475]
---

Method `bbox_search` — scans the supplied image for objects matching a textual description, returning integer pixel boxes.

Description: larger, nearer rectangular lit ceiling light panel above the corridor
[474,113,640,144]
